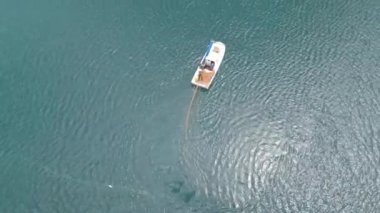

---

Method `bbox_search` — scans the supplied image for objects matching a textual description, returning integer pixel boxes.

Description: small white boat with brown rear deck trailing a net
[191,41,226,89]
